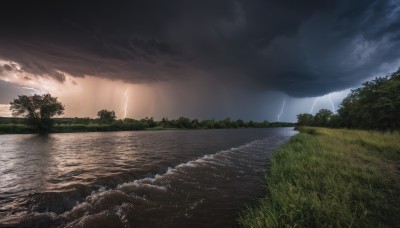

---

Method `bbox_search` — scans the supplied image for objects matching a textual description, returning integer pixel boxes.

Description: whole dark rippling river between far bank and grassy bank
[0,128,295,227]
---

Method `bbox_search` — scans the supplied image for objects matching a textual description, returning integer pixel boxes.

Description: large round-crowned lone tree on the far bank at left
[10,94,64,134]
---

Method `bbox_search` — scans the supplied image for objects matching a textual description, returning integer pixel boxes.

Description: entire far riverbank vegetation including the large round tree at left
[0,94,294,134]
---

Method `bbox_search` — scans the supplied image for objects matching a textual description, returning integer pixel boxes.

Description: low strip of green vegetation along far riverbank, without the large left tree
[0,116,294,134]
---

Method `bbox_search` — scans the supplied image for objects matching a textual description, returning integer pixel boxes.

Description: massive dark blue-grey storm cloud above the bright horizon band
[0,0,400,96]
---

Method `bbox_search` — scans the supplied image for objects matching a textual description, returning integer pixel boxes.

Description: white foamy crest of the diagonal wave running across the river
[18,137,272,226]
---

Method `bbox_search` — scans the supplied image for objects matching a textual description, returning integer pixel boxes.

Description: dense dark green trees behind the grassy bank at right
[297,69,400,130]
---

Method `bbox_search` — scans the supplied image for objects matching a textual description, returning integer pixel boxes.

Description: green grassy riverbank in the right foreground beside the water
[240,127,400,227]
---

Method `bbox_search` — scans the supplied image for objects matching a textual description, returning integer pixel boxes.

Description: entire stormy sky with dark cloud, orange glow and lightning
[0,0,400,121]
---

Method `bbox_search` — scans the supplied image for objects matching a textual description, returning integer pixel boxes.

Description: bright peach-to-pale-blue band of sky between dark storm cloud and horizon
[0,61,350,122]
